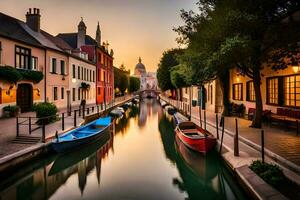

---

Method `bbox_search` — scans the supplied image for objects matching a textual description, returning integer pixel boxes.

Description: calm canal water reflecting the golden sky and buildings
[0,99,245,200]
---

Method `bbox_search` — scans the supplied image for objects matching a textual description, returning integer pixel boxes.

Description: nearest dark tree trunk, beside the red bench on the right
[251,66,263,128]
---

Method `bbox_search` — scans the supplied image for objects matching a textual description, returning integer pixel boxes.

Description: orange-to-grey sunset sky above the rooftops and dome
[0,0,196,71]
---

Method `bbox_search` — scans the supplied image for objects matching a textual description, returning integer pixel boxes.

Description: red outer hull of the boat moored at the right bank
[175,123,216,154]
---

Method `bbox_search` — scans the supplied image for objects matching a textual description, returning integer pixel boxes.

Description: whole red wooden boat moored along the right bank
[175,122,216,153]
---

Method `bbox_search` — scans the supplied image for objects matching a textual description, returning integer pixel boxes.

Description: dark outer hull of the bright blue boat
[52,126,110,153]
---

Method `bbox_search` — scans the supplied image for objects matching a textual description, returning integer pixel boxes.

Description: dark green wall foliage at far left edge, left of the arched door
[0,66,22,84]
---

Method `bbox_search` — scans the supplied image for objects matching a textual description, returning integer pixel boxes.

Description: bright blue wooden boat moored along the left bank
[52,117,111,153]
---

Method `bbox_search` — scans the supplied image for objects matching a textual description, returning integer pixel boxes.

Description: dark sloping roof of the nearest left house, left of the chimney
[0,12,41,46]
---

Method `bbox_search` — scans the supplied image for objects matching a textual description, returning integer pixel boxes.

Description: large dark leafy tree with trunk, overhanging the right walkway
[175,0,299,127]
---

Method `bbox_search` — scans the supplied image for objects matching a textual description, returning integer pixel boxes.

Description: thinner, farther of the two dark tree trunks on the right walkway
[218,70,230,116]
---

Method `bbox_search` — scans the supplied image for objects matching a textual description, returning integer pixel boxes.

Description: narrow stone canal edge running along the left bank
[0,96,134,178]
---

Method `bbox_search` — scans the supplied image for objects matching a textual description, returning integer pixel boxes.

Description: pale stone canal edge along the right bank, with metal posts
[162,98,300,199]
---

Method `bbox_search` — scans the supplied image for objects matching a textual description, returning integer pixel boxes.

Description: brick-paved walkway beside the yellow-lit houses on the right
[161,97,300,170]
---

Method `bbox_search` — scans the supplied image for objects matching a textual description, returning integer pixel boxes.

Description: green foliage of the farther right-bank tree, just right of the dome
[157,49,183,91]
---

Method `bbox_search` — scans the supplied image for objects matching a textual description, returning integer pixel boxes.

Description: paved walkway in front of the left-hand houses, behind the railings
[0,96,132,158]
